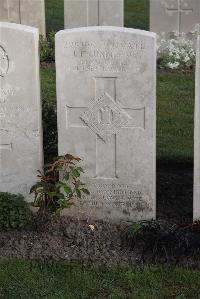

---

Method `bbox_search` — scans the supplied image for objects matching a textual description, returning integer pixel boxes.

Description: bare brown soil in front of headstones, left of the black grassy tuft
[0,217,141,265]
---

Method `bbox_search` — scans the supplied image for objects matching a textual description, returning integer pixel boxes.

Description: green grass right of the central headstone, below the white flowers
[157,74,195,162]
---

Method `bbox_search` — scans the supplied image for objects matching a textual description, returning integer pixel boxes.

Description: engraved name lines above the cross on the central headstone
[64,39,146,73]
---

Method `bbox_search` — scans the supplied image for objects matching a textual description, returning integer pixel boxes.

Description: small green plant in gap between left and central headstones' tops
[40,31,55,63]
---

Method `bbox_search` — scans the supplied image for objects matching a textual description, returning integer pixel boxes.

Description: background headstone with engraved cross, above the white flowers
[150,0,200,35]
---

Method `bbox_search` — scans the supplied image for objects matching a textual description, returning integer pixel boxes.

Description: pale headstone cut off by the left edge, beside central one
[0,23,43,199]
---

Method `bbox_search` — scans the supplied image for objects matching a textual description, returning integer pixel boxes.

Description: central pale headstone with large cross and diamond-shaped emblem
[56,27,156,221]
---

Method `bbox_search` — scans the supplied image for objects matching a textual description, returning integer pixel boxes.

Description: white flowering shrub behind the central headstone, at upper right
[157,33,197,70]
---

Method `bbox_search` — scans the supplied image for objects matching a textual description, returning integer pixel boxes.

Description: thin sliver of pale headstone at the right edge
[193,37,200,220]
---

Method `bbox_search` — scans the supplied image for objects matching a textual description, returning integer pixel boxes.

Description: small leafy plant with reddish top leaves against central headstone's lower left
[30,154,90,214]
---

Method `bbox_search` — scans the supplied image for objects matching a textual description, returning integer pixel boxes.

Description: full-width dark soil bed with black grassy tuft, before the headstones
[0,218,200,269]
